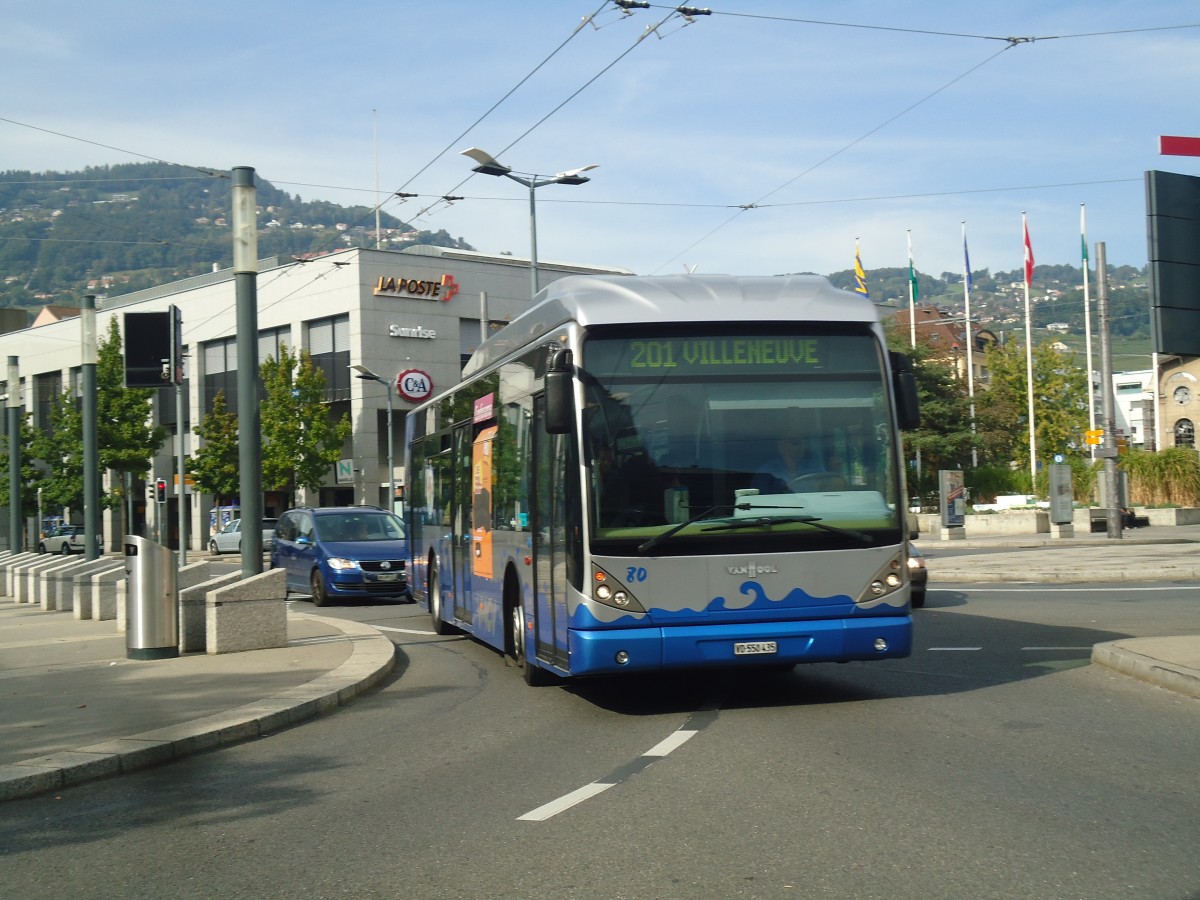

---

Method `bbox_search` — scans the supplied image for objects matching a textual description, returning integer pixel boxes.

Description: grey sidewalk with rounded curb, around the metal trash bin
[0,598,395,800]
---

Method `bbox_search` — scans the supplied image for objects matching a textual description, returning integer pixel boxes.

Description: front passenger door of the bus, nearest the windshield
[535,397,569,668]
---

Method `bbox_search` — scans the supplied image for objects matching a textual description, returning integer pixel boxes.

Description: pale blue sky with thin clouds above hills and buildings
[0,0,1200,282]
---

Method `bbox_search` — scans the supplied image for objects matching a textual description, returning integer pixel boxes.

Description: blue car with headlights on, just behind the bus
[271,506,413,606]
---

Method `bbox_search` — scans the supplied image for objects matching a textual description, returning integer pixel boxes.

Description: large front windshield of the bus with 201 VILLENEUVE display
[581,323,901,554]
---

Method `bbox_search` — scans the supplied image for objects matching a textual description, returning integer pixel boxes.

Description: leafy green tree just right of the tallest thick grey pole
[260,347,350,504]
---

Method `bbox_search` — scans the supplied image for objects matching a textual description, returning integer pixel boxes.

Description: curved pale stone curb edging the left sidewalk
[0,613,396,802]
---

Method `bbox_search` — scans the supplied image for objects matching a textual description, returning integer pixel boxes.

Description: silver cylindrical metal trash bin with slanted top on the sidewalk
[125,534,179,659]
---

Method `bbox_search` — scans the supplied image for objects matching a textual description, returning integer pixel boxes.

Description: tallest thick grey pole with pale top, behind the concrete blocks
[233,166,263,578]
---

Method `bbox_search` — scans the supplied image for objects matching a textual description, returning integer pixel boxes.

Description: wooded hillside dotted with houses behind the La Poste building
[0,163,470,308]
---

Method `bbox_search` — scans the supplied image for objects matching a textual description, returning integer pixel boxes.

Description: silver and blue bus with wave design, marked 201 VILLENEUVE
[406,276,919,684]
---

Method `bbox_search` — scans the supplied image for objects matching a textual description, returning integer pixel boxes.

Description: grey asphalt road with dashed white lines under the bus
[0,584,1200,899]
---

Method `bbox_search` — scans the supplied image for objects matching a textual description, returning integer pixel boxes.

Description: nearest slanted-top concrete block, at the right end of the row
[205,569,288,653]
